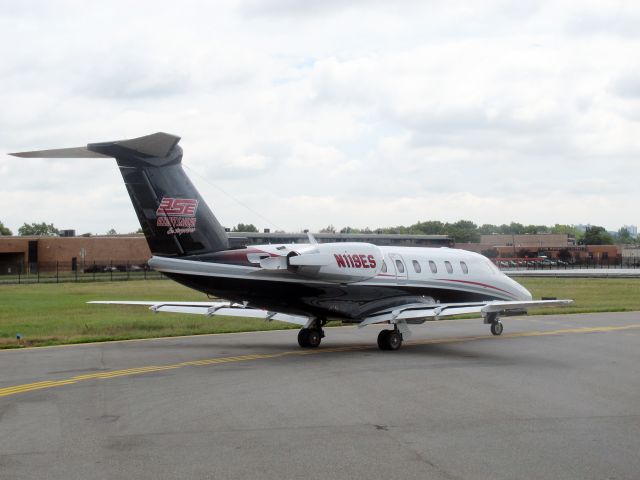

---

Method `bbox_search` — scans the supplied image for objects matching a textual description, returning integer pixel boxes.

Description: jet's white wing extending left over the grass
[87,300,309,326]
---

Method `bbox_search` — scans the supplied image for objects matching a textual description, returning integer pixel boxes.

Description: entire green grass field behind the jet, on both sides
[0,278,640,348]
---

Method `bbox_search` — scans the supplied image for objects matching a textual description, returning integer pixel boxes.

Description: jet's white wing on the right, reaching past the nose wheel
[358,300,573,327]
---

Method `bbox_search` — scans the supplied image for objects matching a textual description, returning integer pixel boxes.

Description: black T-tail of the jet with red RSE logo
[11,133,229,256]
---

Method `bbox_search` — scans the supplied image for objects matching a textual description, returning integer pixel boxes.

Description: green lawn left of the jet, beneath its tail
[0,280,296,348]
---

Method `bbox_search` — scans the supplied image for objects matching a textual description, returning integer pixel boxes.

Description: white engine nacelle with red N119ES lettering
[287,242,383,283]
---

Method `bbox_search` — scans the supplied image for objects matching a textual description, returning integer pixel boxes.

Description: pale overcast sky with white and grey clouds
[0,0,640,233]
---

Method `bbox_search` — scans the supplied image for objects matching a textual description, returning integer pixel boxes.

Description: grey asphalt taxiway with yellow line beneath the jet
[0,312,640,480]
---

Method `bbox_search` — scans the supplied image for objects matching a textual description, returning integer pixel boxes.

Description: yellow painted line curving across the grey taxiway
[0,324,640,397]
